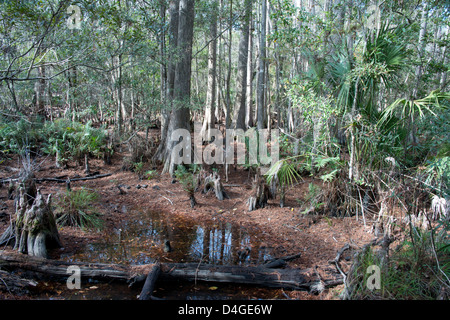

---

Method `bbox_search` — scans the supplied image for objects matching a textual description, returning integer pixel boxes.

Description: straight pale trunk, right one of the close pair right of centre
[256,0,267,129]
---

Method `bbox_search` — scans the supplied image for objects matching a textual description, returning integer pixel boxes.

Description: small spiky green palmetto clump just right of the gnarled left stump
[54,188,103,230]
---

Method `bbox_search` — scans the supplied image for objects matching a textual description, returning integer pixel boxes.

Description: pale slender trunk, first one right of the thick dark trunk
[201,0,218,141]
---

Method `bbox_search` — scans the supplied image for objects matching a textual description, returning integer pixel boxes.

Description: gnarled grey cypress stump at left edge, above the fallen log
[0,172,61,258]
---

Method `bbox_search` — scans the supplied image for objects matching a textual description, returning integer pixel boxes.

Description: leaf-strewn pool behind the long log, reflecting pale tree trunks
[71,212,261,264]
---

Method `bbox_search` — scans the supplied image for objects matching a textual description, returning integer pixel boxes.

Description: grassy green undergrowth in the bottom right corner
[352,219,450,300]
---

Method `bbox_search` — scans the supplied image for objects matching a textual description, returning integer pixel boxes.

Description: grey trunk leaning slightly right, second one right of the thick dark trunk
[233,0,252,129]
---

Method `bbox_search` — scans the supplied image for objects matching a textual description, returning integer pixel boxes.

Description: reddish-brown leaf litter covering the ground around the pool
[0,134,374,299]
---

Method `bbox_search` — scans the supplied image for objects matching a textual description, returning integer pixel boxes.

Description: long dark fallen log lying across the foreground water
[0,252,343,290]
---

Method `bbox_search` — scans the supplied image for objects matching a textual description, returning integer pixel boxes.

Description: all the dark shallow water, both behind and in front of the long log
[35,208,284,300]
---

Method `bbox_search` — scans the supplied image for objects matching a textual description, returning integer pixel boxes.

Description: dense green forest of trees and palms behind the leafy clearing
[0,0,450,300]
